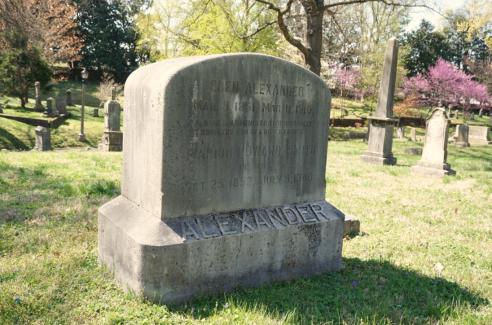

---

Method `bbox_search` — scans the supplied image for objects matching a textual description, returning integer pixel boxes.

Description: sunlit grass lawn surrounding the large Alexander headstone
[0,140,492,324]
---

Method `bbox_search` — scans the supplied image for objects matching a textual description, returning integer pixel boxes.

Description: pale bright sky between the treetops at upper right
[406,0,468,31]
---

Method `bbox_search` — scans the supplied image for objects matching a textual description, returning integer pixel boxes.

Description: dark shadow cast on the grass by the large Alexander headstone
[172,258,489,324]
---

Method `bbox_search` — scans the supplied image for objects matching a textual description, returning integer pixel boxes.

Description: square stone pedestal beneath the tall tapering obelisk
[361,117,398,165]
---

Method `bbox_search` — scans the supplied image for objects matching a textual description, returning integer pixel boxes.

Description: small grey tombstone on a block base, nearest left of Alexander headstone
[99,88,123,151]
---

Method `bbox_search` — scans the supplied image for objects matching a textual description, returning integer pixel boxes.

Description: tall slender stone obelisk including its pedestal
[361,38,398,165]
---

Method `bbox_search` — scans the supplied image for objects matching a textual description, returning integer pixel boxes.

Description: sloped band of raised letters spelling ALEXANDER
[166,202,332,240]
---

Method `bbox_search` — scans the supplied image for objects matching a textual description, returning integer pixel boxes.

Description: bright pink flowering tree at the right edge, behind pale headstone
[404,59,490,109]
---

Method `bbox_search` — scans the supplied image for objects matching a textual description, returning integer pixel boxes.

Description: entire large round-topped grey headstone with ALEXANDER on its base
[99,54,344,303]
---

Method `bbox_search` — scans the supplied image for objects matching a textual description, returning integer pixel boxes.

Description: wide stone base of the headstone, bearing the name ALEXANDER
[99,196,344,304]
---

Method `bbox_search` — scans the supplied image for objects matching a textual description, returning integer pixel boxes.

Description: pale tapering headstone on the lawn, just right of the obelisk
[412,107,456,177]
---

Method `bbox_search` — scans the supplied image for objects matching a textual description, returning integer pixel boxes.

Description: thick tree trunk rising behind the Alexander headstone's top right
[302,0,324,76]
